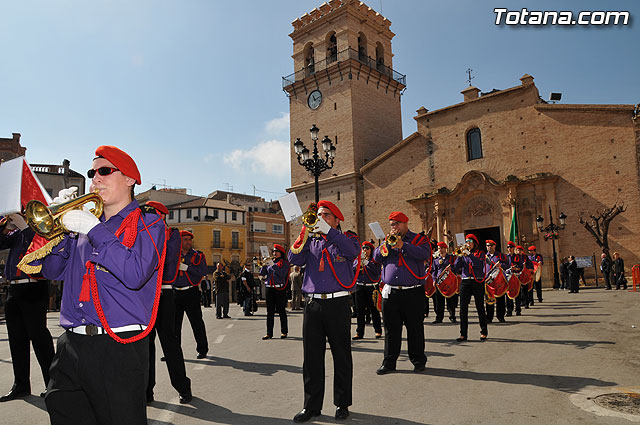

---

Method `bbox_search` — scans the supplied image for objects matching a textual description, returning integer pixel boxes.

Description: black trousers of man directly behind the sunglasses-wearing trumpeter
[147,289,191,398]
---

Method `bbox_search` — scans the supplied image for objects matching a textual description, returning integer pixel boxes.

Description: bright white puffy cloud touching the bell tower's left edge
[223,139,291,180]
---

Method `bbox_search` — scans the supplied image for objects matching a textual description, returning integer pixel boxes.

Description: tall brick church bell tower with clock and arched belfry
[282,0,406,235]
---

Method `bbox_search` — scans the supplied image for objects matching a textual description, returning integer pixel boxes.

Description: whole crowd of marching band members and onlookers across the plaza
[0,146,626,424]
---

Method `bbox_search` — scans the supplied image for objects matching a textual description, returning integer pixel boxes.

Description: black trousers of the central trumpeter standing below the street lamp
[302,296,353,411]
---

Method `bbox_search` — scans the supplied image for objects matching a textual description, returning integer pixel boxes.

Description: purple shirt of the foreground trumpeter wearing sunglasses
[36,200,165,328]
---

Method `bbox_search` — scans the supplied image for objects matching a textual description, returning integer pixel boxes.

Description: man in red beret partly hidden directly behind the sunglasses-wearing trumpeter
[146,201,193,404]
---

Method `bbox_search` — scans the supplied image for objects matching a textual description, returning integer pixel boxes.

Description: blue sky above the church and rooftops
[0,0,640,199]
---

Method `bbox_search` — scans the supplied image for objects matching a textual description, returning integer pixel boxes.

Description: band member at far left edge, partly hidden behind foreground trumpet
[0,213,54,402]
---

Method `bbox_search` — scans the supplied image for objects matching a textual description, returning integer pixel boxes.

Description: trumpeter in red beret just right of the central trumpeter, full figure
[373,211,431,375]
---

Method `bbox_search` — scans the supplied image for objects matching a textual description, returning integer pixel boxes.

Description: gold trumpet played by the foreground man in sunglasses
[25,192,104,240]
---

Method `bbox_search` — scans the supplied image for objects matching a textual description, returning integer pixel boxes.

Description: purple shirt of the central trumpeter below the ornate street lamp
[288,228,360,294]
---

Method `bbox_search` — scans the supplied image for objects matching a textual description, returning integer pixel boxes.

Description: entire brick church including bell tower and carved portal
[285,0,640,286]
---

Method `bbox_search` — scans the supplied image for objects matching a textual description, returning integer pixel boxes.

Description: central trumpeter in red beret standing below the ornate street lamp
[289,200,360,422]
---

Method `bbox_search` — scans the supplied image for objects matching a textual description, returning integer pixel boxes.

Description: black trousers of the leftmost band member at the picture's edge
[5,281,54,391]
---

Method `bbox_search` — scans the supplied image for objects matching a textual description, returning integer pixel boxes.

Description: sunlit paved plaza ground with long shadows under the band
[0,287,640,425]
